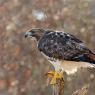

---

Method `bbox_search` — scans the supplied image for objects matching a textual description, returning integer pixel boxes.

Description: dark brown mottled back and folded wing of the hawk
[38,31,95,64]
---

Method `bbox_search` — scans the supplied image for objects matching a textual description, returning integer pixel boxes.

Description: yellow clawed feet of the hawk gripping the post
[46,71,64,85]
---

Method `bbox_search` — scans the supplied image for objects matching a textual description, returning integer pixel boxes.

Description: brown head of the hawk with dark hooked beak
[25,28,45,41]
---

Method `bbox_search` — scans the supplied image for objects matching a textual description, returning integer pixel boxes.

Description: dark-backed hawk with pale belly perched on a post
[25,28,95,84]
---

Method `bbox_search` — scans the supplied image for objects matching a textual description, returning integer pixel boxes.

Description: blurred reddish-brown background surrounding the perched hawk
[0,0,95,95]
